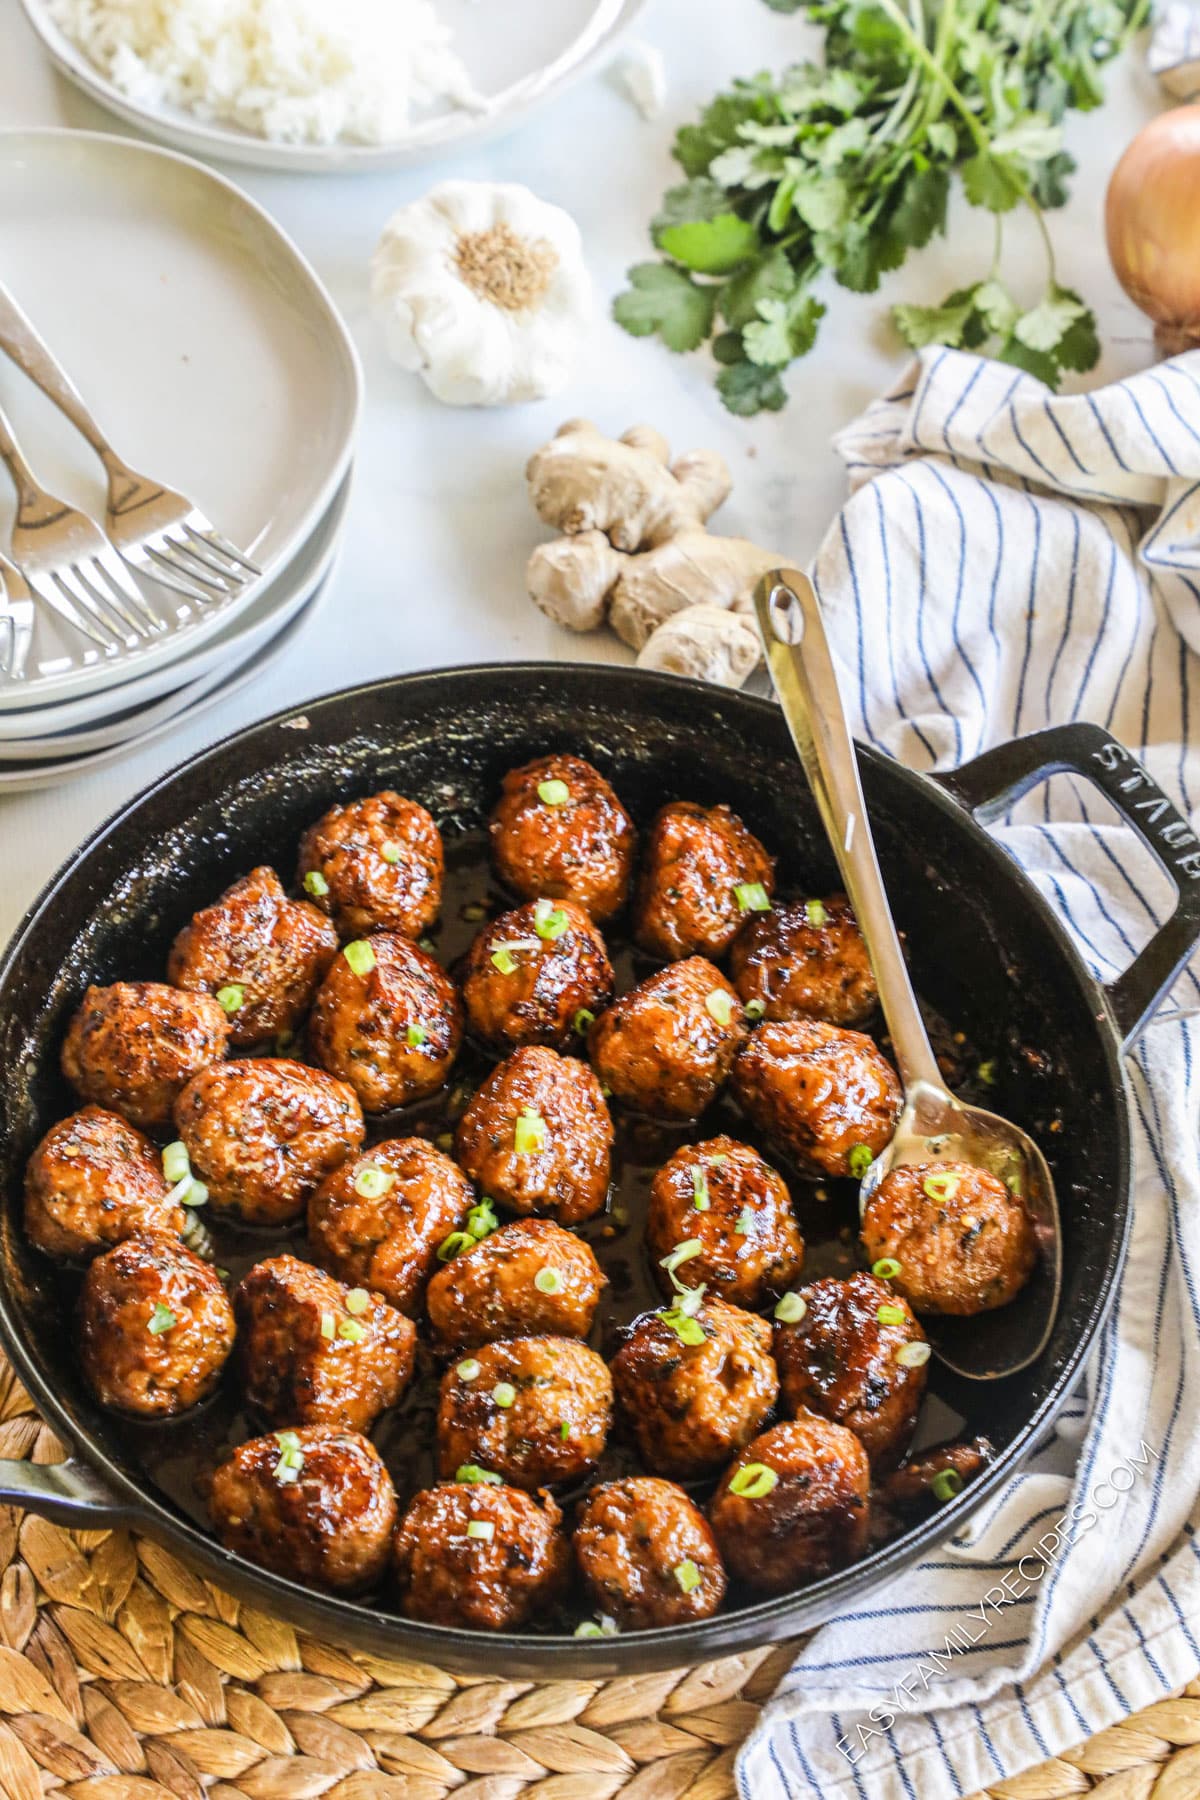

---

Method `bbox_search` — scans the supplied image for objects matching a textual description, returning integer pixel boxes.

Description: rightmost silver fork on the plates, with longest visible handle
[0,283,263,603]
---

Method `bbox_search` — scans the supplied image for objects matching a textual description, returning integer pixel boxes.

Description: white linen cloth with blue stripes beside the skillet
[738,349,1200,1800]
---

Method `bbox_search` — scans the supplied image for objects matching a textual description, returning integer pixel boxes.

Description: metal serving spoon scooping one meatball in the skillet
[754,569,1061,1381]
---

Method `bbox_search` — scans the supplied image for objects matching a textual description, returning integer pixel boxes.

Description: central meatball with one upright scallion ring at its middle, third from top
[455,1046,613,1226]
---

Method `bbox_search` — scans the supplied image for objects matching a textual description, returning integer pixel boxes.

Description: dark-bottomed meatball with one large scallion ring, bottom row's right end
[709,1413,871,1593]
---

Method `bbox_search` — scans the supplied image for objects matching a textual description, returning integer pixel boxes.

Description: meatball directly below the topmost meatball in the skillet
[462,900,612,1055]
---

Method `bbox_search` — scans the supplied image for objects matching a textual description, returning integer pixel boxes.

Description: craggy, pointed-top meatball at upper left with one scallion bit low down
[167,868,338,1048]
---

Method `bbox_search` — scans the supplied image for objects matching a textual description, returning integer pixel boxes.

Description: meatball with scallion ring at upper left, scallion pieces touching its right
[308,1138,475,1312]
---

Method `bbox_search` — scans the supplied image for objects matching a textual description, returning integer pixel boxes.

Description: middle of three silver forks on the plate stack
[0,396,162,653]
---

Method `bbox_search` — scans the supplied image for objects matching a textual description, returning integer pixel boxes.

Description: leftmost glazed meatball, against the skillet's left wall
[25,1107,184,1258]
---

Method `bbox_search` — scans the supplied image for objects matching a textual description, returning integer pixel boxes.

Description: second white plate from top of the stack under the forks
[0,472,353,745]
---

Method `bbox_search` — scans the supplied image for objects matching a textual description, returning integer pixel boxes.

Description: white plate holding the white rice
[22,0,644,175]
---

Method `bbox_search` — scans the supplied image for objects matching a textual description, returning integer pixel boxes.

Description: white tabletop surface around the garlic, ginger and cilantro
[0,0,1159,941]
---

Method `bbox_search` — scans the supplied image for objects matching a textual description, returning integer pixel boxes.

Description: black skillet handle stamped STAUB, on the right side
[936,724,1200,1051]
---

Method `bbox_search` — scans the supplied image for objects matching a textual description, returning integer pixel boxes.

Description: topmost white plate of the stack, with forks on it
[0,130,362,711]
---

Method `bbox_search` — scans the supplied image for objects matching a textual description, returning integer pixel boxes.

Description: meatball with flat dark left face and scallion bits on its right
[234,1256,417,1431]
